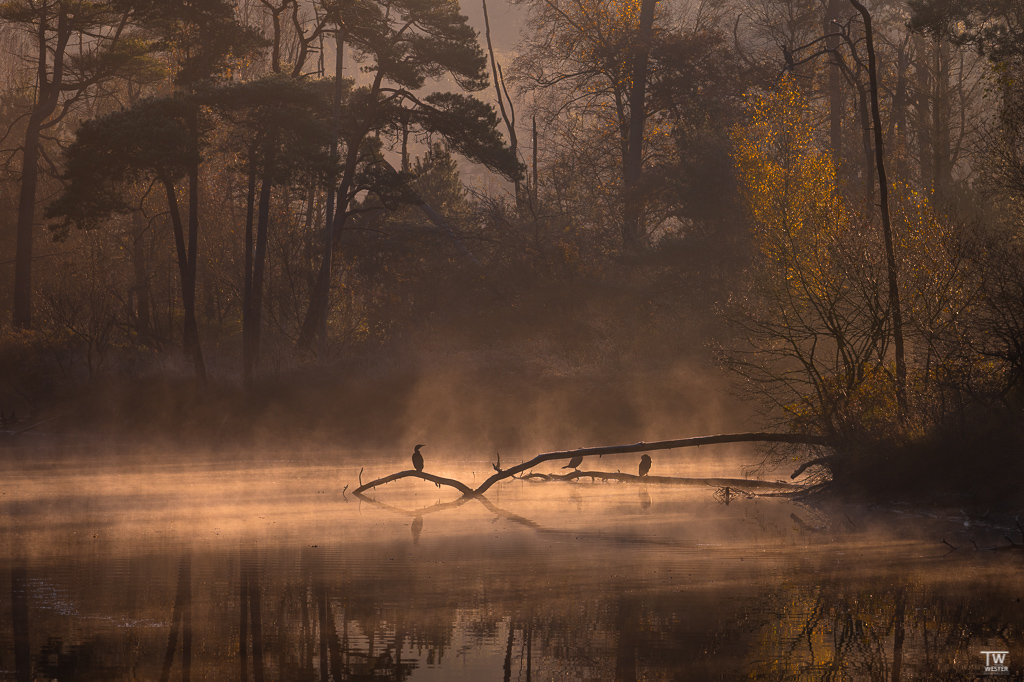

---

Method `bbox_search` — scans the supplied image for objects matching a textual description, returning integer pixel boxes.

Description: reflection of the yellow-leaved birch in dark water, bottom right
[750,578,1024,680]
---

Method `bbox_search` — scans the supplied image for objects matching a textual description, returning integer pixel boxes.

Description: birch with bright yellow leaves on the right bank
[726,77,977,439]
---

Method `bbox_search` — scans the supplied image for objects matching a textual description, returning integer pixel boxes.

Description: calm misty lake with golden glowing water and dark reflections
[0,446,1024,681]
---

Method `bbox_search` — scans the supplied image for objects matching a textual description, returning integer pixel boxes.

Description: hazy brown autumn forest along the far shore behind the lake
[0,0,1024,495]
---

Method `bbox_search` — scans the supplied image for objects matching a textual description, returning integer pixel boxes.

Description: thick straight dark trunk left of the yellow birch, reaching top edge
[623,0,657,251]
